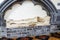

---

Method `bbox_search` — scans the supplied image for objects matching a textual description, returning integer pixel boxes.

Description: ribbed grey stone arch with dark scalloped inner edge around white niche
[0,0,57,27]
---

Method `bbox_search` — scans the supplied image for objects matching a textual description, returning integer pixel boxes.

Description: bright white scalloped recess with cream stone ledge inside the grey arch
[4,1,50,28]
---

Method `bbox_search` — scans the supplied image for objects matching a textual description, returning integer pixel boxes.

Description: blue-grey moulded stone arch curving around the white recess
[0,0,57,26]
